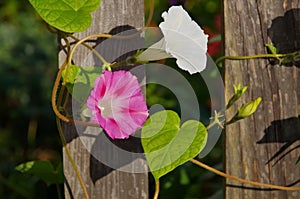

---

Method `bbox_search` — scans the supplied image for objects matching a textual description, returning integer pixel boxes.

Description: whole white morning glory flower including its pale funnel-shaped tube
[137,6,208,74]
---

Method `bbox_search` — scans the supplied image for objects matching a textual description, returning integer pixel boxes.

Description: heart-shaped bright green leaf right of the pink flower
[142,110,207,180]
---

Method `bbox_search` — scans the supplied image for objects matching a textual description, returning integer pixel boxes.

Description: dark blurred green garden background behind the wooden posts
[0,0,223,199]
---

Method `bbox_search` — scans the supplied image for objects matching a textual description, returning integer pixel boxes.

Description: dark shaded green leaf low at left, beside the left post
[15,161,64,186]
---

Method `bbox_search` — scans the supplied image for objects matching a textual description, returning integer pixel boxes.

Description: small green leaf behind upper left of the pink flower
[62,65,102,102]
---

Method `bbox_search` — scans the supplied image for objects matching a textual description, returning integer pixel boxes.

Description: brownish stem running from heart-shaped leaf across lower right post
[190,159,300,191]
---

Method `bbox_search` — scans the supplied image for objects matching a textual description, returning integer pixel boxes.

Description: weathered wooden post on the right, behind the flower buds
[224,0,300,199]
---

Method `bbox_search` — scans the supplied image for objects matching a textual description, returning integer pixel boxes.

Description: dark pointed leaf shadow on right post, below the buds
[257,116,300,164]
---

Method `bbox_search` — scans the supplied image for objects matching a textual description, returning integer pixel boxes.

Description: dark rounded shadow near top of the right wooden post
[267,9,300,67]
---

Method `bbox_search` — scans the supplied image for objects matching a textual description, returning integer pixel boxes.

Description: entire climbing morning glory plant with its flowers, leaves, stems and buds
[16,0,300,198]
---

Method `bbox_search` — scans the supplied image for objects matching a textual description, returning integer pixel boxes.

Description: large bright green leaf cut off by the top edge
[29,0,100,33]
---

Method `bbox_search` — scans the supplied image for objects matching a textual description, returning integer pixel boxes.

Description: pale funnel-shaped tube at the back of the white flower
[137,38,172,61]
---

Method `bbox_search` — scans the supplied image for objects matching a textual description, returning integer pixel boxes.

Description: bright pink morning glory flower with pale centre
[87,70,148,139]
